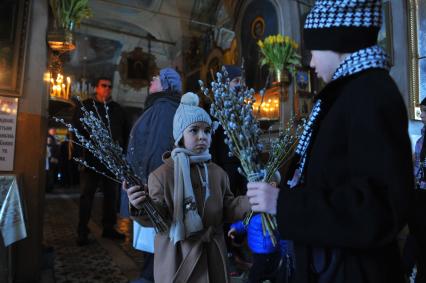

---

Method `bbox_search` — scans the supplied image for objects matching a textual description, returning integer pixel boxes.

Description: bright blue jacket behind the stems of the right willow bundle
[231,214,287,255]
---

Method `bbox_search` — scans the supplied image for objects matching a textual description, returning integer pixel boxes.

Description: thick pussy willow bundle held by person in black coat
[199,69,303,245]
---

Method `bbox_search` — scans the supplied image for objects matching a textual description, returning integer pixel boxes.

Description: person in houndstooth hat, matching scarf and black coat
[247,0,413,283]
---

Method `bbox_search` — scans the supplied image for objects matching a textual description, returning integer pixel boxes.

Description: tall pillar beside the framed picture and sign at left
[6,0,48,283]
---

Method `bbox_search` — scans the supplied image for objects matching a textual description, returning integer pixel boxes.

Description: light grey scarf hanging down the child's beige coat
[169,147,211,244]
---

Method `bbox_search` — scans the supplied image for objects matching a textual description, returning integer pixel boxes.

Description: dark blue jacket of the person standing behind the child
[120,93,181,216]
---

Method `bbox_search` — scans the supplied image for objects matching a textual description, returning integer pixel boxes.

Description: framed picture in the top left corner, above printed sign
[0,0,30,96]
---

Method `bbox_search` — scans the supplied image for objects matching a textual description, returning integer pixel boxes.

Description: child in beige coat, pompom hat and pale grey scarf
[127,93,250,283]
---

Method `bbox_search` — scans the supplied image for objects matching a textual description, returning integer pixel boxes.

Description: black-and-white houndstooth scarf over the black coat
[287,45,390,188]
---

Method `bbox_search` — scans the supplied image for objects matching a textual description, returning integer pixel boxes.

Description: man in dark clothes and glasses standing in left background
[73,77,129,245]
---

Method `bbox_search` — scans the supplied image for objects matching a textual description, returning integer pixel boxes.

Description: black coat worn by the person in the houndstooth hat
[277,69,413,283]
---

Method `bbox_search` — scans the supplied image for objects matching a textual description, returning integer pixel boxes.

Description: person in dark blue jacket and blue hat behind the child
[125,68,182,282]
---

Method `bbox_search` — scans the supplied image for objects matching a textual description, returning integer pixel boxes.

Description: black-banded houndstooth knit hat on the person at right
[303,0,382,53]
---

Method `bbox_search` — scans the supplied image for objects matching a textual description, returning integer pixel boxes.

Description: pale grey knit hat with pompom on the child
[173,92,212,145]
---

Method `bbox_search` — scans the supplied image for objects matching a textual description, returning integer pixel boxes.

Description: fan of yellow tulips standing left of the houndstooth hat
[257,34,300,80]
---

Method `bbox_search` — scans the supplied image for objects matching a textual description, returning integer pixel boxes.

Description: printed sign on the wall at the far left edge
[0,96,18,171]
